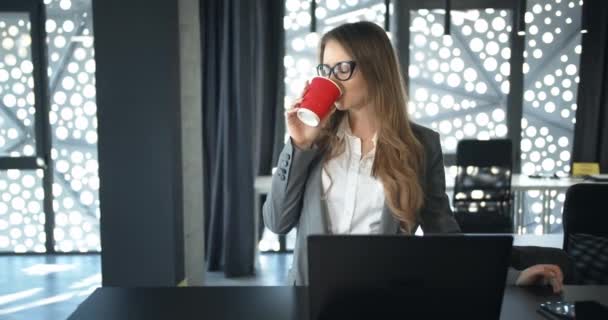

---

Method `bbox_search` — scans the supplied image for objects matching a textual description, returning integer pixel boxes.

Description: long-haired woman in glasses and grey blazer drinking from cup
[263,22,562,291]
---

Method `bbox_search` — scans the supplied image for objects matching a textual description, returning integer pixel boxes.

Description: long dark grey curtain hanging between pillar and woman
[200,0,284,277]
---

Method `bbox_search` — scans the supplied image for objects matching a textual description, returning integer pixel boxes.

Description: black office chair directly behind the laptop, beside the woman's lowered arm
[453,139,513,233]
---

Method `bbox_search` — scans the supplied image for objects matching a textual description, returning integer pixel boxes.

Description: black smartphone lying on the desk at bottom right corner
[538,301,608,320]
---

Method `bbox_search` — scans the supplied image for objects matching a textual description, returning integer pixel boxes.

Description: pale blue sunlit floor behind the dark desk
[0,253,292,320]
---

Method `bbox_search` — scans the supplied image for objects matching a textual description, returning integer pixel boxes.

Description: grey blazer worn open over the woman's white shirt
[263,124,516,285]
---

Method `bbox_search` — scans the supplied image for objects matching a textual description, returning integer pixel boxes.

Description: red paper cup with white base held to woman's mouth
[297,77,342,127]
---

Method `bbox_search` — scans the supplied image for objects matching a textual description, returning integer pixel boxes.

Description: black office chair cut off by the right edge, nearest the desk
[562,183,608,285]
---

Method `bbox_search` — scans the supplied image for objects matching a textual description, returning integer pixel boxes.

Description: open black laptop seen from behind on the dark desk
[308,234,513,320]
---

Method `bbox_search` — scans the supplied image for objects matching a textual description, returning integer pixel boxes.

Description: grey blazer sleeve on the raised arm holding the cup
[262,139,320,234]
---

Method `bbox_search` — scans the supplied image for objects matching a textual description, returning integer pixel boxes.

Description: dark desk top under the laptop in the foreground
[69,286,608,320]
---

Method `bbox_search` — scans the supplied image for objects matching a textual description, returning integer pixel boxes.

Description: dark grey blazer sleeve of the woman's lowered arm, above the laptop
[418,130,460,234]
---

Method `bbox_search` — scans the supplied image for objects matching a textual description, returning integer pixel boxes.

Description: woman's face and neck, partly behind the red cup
[322,40,368,111]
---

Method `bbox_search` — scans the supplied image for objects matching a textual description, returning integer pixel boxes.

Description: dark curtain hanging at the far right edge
[573,0,608,173]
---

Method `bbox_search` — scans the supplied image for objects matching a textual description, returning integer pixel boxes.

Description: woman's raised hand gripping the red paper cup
[285,81,335,149]
